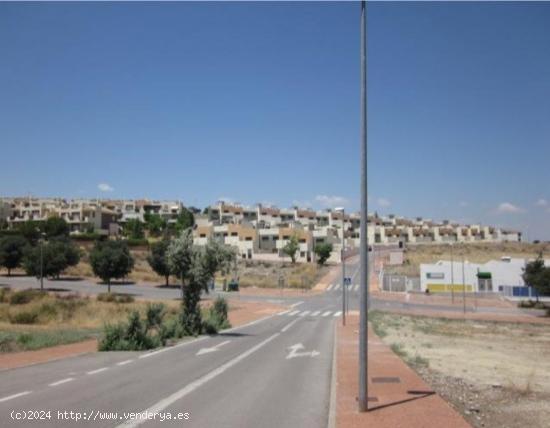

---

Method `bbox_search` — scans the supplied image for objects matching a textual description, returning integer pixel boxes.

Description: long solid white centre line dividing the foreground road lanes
[117,333,281,428]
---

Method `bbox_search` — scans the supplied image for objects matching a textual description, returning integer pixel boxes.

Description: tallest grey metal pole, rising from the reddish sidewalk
[358,0,370,412]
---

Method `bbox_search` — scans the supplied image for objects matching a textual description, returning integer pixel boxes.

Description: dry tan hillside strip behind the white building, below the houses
[385,242,550,276]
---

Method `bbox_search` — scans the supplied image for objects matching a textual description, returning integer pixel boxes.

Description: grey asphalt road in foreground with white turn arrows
[0,293,341,428]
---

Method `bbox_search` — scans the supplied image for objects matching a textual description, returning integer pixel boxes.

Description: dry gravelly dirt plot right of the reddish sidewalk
[371,312,550,428]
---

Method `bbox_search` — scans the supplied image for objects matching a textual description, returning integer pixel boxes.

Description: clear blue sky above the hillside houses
[0,2,550,239]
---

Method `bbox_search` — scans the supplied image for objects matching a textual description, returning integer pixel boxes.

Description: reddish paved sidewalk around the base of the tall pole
[335,314,470,428]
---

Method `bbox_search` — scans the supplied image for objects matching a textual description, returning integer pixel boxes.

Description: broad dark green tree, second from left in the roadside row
[23,238,80,278]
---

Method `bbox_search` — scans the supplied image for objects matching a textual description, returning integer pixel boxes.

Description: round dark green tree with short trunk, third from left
[90,241,134,293]
